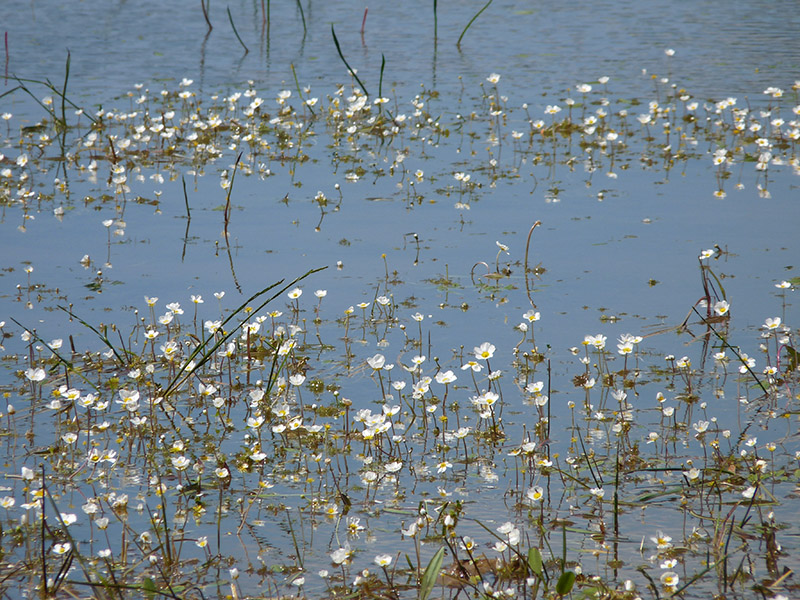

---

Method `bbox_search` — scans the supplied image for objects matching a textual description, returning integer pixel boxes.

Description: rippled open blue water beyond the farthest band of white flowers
[3,0,800,103]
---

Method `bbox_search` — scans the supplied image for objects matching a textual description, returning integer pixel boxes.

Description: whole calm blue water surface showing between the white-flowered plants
[0,2,800,595]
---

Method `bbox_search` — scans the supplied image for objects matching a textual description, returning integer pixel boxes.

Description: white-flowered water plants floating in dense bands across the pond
[0,62,800,600]
